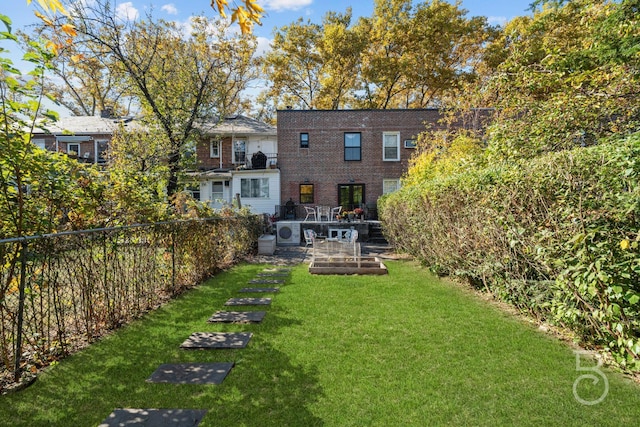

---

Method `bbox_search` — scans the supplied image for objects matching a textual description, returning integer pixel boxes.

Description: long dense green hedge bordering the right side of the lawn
[380,134,640,371]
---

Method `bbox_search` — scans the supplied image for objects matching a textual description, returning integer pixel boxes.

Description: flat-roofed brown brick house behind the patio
[278,109,486,219]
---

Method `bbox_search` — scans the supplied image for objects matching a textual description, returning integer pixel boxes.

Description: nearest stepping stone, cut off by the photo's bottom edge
[98,408,207,427]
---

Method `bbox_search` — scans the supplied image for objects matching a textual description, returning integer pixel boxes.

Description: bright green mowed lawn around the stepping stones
[0,261,640,427]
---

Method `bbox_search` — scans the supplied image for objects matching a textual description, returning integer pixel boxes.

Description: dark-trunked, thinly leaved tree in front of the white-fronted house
[63,0,256,196]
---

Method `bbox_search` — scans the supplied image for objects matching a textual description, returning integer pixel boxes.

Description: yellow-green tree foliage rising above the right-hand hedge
[474,0,640,158]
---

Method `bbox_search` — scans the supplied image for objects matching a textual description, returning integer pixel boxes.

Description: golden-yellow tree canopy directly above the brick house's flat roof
[263,0,496,109]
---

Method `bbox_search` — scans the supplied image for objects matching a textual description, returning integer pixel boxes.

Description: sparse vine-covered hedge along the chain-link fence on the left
[0,216,262,392]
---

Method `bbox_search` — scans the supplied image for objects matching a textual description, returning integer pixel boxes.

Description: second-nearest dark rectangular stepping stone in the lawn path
[147,362,233,384]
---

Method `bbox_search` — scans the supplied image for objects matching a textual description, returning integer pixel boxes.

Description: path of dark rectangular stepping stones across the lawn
[98,268,291,427]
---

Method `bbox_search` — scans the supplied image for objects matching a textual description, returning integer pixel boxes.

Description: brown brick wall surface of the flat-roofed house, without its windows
[278,109,458,212]
